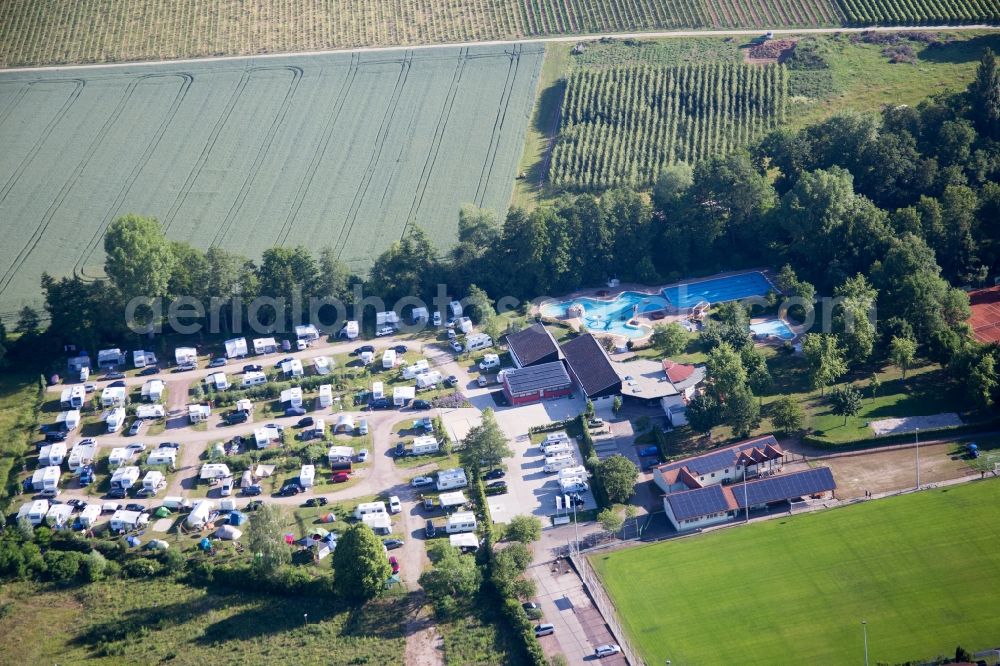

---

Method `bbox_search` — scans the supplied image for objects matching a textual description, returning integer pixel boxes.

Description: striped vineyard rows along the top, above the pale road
[0,0,1000,67]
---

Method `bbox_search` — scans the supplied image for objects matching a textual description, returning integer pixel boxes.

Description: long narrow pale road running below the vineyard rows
[0,24,1000,73]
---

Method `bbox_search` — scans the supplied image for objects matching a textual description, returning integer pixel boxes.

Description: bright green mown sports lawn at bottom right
[591,481,1000,665]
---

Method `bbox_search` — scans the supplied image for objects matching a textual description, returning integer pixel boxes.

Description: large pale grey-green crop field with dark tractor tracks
[0,45,543,314]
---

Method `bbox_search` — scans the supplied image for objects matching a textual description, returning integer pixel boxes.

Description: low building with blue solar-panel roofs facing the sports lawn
[663,467,837,531]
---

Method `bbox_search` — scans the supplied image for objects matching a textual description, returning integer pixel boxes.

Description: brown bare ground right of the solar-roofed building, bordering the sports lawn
[814,444,974,499]
